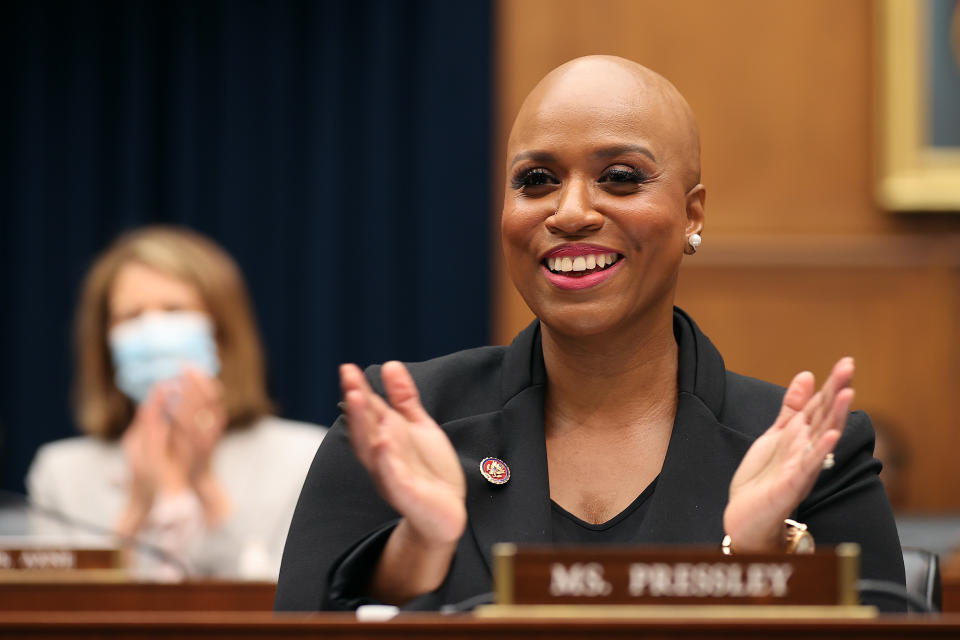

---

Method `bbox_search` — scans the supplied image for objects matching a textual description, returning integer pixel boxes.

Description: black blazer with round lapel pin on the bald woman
[275,309,904,611]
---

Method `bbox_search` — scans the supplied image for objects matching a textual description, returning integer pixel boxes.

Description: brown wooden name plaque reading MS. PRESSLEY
[494,544,860,606]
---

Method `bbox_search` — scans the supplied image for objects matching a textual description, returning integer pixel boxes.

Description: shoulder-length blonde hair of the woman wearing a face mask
[73,226,273,439]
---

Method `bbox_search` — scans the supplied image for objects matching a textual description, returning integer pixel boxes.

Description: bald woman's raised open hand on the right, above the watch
[723,358,854,553]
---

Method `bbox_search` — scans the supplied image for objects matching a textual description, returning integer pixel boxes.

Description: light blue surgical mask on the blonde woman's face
[109,311,220,404]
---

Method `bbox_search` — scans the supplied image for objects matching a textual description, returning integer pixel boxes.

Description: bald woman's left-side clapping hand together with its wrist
[340,362,467,605]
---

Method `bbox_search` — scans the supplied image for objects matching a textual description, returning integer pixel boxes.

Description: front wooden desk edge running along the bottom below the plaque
[0,612,960,640]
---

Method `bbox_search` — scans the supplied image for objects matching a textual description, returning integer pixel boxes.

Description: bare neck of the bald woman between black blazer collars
[542,307,677,436]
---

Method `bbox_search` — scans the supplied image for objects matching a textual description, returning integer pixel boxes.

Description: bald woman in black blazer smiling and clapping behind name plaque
[276,56,904,610]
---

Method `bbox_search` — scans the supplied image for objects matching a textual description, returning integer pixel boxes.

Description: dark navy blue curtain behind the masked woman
[0,0,491,489]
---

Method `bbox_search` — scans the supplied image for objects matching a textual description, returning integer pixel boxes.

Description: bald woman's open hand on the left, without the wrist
[340,361,467,545]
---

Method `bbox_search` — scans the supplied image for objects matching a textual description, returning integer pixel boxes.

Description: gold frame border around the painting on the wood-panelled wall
[877,0,960,212]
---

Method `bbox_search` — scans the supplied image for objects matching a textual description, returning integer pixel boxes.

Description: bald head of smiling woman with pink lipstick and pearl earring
[501,58,706,344]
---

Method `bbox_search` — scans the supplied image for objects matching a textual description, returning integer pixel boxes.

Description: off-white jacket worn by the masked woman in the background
[26,416,326,581]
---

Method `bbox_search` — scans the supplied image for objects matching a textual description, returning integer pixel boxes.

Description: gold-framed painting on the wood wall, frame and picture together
[877,0,960,212]
